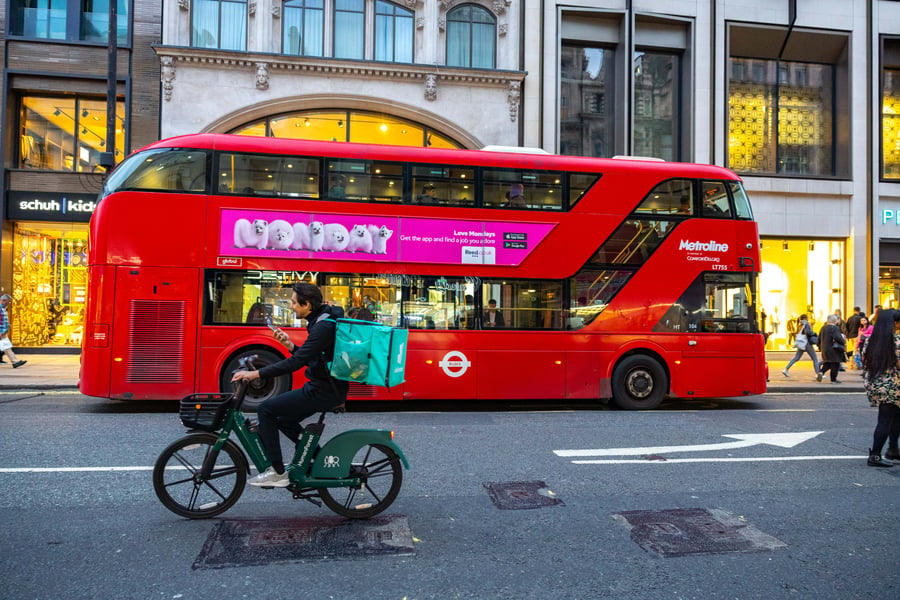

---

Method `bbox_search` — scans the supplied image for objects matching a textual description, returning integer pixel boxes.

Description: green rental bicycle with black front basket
[153,356,409,519]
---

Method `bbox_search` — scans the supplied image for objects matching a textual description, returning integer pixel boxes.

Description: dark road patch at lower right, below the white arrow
[613,508,787,556]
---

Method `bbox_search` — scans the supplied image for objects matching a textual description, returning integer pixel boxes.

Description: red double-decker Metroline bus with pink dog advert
[79,134,767,409]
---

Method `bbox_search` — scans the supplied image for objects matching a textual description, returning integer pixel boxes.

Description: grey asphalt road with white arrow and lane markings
[0,393,900,600]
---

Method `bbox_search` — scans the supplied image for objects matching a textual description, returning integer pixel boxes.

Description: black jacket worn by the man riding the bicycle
[259,304,344,387]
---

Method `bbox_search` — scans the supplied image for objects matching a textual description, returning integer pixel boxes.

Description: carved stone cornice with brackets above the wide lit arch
[153,45,527,100]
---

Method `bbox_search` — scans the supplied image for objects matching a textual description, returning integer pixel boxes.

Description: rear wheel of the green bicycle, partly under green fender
[319,444,403,519]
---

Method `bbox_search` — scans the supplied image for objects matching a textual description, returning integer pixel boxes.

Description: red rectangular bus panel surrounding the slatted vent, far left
[110,266,200,400]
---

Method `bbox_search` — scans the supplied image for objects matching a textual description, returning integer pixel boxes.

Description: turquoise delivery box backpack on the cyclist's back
[331,319,409,387]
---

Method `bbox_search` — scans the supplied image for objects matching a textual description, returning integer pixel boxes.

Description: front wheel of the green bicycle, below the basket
[153,432,248,519]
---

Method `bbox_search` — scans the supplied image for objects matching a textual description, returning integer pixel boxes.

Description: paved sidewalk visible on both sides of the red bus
[0,352,865,392]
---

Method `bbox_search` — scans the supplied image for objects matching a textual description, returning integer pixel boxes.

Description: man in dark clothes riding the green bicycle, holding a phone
[231,283,350,487]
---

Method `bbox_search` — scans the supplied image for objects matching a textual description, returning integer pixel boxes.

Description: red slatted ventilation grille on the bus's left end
[128,300,184,383]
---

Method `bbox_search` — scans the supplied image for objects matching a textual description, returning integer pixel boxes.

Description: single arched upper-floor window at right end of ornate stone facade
[447,4,497,69]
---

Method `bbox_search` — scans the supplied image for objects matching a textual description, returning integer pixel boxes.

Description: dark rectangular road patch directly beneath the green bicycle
[193,515,415,569]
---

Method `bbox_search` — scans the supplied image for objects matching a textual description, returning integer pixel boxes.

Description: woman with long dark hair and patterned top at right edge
[862,310,900,467]
